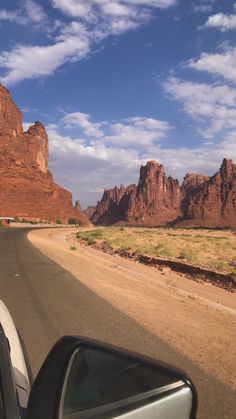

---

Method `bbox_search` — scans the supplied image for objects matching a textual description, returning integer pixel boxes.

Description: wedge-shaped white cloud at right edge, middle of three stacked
[187,48,236,82]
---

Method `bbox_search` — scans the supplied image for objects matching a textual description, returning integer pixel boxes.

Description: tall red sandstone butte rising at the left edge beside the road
[0,85,88,224]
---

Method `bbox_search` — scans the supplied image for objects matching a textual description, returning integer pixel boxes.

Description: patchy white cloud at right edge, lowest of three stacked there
[163,76,236,138]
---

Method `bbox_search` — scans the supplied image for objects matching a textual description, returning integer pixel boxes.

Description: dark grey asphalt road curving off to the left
[0,228,236,419]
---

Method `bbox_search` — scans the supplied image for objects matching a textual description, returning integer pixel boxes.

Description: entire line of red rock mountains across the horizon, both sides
[0,85,236,227]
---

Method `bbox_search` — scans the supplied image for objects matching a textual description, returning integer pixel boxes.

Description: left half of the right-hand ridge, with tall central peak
[91,161,181,225]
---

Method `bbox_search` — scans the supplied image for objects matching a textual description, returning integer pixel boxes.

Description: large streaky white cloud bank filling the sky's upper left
[0,0,176,85]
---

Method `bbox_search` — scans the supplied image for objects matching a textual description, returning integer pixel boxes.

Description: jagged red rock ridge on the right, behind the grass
[88,159,236,228]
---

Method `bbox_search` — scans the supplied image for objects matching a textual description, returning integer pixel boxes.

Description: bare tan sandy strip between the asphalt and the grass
[28,228,236,389]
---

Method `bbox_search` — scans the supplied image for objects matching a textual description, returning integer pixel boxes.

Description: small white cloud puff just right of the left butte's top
[61,112,103,137]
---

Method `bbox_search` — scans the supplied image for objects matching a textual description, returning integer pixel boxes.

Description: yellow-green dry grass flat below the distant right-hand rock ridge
[78,227,236,275]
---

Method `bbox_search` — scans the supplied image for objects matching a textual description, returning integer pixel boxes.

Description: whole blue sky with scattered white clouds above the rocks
[0,0,236,207]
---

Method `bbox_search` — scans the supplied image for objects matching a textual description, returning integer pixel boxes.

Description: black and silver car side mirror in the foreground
[27,336,197,419]
